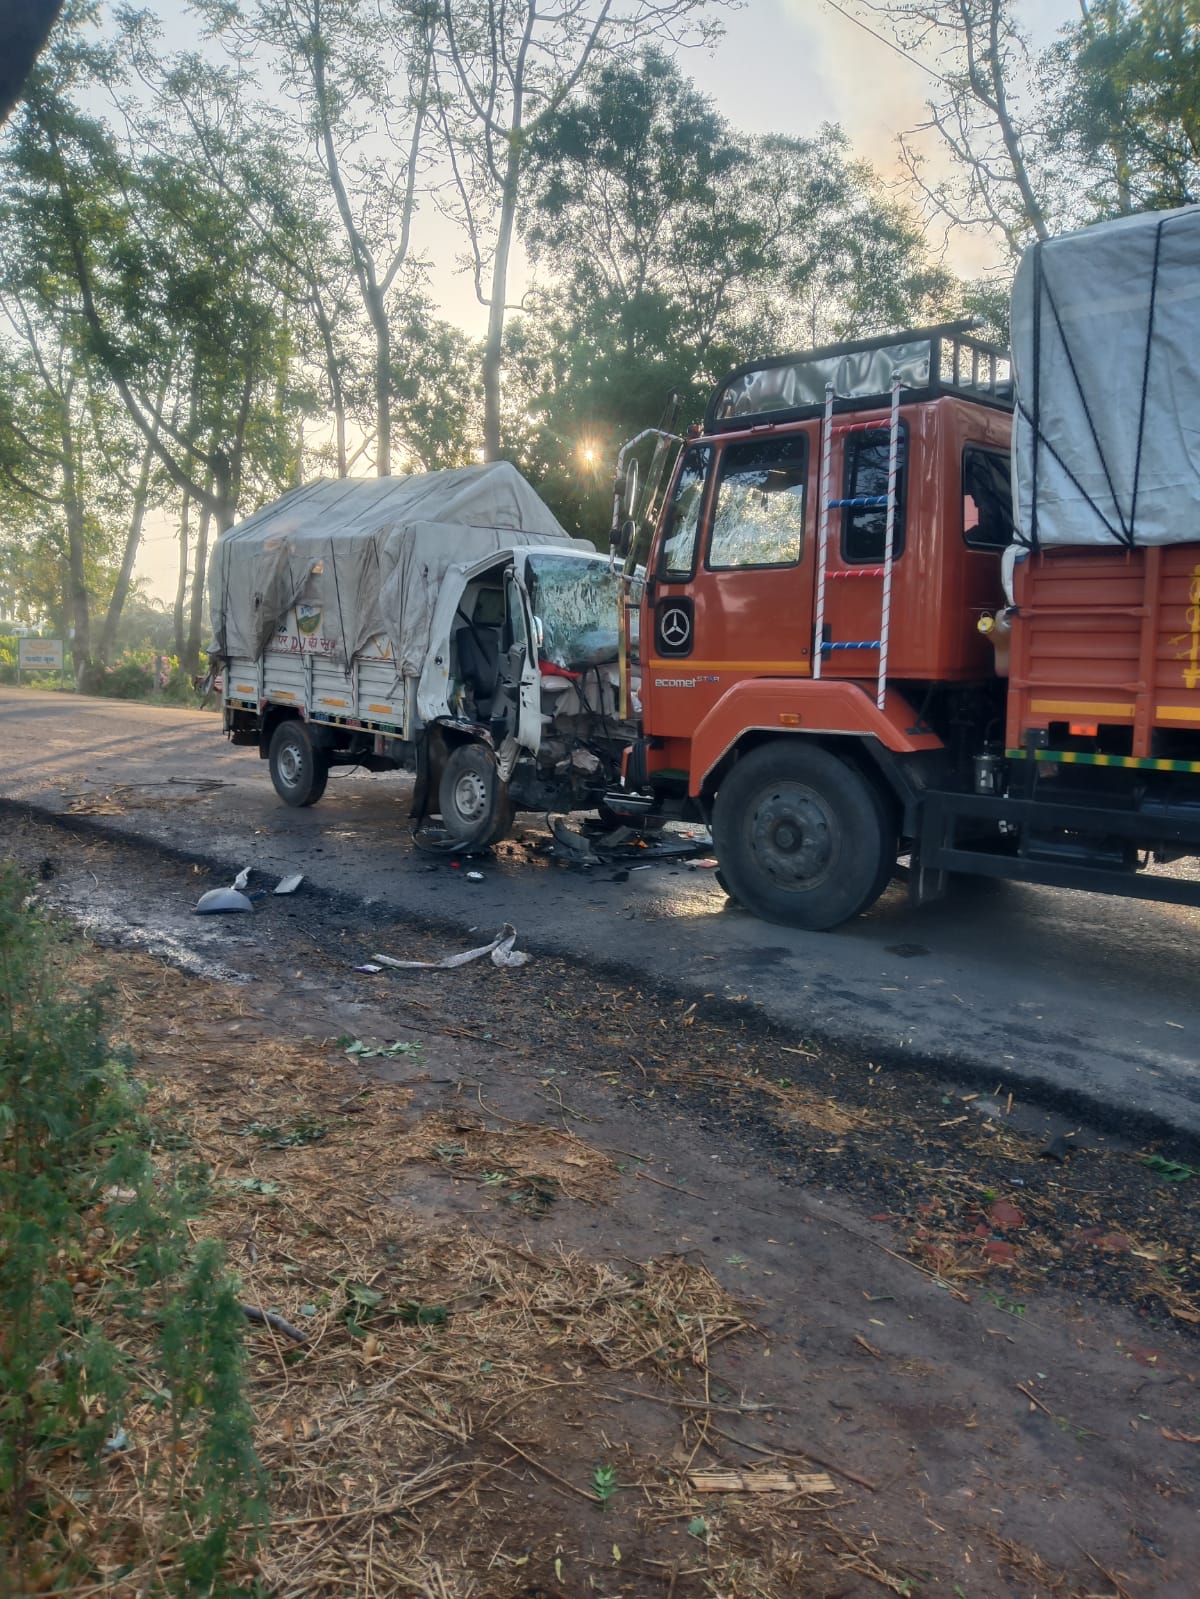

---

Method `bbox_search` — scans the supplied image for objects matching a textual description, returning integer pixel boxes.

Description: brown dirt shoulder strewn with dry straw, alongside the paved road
[6,822,1200,1599]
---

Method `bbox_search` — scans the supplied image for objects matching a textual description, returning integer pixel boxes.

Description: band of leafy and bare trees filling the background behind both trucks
[0,0,1200,676]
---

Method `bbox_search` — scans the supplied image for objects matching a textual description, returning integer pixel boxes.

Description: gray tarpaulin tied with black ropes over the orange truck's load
[1013,206,1200,545]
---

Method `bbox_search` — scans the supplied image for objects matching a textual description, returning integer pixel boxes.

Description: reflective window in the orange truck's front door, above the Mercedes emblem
[709,433,808,571]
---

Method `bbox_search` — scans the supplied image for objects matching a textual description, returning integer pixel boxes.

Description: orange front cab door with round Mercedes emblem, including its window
[643,430,813,737]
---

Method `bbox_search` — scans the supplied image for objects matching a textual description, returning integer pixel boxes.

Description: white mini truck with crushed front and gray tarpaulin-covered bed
[208,462,632,849]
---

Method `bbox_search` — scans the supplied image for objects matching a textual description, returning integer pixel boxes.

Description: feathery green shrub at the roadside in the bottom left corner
[0,863,266,1594]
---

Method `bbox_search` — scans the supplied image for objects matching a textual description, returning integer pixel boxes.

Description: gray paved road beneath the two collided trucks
[0,688,1200,1135]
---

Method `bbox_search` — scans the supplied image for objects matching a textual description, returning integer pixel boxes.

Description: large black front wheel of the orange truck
[712,739,896,932]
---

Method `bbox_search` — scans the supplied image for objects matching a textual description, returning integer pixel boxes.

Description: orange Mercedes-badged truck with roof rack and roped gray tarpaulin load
[605,208,1200,929]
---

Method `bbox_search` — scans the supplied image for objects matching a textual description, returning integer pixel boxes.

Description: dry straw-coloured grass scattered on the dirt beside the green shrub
[40,955,902,1599]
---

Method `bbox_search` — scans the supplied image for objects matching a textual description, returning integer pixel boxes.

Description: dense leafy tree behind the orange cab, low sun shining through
[518,50,954,537]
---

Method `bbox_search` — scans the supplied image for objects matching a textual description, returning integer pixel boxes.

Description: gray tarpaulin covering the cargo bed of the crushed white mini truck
[208,462,592,676]
